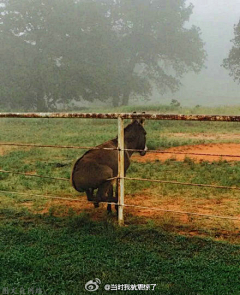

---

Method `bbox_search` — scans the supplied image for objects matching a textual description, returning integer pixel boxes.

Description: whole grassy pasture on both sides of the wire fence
[0,107,240,295]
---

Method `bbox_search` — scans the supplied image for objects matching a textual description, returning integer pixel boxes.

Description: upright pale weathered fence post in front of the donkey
[117,116,124,226]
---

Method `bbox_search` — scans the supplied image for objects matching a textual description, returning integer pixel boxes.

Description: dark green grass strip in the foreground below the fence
[0,213,240,295]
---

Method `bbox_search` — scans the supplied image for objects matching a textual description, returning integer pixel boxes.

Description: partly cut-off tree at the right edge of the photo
[223,21,240,83]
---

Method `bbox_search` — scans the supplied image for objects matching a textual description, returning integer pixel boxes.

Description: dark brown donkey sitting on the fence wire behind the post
[72,120,147,212]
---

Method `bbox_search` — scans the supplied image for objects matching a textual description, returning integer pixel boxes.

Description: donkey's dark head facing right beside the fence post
[124,119,147,156]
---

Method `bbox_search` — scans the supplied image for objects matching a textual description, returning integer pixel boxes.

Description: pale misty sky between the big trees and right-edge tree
[162,0,240,106]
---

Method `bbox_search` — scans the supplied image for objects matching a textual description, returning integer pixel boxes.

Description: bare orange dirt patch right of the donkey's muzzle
[132,143,240,162]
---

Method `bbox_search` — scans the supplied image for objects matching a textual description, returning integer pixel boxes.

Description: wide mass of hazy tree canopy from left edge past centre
[0,0,205,111]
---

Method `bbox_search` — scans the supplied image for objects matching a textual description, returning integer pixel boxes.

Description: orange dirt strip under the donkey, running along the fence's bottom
[23,190,240,242]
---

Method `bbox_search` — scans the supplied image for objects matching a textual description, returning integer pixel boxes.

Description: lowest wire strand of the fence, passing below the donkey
[0,190,240,221]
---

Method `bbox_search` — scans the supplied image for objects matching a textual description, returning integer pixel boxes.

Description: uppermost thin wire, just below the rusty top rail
[0,142,240,158]
